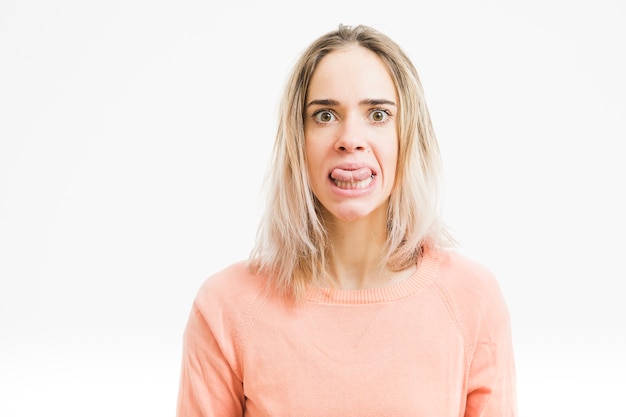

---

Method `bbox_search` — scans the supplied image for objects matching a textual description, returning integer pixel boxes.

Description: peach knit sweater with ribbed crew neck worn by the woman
[177,245,517,417]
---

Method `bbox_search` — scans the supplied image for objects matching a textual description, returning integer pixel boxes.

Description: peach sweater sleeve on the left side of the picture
[176,303,244,417]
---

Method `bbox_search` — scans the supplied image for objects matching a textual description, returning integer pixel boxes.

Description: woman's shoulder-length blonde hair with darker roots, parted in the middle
[249,25,452,297]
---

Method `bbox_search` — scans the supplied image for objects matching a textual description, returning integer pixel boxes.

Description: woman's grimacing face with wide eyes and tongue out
[304,47,398,221]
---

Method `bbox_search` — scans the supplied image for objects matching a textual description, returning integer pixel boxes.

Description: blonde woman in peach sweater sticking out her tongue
[178,26,516,417]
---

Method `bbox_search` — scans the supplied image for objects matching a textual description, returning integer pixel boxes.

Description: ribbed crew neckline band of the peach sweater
[306,248,439,304]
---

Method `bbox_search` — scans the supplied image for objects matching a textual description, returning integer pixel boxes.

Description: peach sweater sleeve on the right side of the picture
[465,276,517,417]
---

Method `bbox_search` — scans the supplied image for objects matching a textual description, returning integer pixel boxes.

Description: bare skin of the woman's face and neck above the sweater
[304,46,414,289]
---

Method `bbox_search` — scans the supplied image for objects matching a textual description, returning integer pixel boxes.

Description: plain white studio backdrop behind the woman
[0,0,626,417]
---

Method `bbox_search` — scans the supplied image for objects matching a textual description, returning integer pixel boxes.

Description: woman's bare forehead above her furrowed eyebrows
[307,46,396,101]
